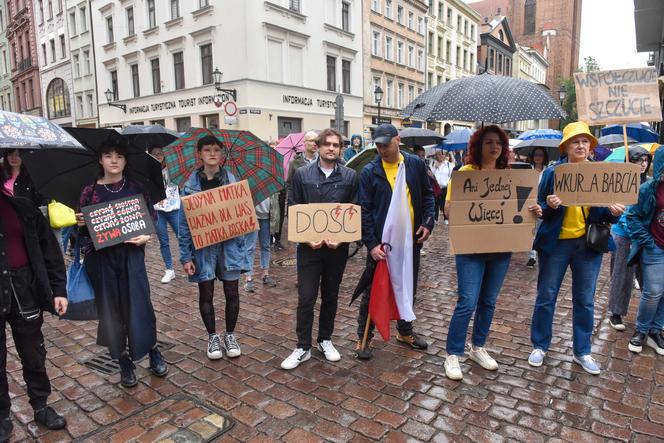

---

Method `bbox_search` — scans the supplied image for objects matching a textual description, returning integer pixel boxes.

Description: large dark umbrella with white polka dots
[403,74,566,123]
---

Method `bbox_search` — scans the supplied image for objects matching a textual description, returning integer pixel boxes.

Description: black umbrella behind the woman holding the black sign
[21,128,166,208]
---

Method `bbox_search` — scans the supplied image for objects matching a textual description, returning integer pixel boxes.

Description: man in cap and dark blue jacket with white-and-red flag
[356,124,435,360]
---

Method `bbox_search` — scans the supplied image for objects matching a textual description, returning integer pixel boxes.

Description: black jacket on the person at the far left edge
[0,193,67,315]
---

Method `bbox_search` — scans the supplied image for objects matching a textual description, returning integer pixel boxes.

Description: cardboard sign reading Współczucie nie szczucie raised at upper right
[574,68,662,126]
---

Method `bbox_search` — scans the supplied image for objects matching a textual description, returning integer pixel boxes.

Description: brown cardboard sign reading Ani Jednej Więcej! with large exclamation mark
[449,169,538,254]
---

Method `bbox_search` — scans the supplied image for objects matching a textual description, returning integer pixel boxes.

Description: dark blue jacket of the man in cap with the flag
[360,152,435,250]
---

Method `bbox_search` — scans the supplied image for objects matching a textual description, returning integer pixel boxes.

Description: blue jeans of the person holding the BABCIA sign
[530,236,602,357]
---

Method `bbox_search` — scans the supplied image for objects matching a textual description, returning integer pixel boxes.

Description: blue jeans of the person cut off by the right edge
[636,246,664,334]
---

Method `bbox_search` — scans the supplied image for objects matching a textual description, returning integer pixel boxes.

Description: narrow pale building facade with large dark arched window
[33,0,75,126]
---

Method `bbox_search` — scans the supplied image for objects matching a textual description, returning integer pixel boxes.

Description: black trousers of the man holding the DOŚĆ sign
[296,244,348,350]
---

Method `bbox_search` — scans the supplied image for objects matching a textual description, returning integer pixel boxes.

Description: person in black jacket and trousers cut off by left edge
[0,166,67,443]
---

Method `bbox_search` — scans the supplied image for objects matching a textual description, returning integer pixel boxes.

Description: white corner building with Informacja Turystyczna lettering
[90,0,362,140]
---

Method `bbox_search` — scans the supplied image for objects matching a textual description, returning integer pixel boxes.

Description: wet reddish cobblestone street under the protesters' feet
[7,225,664,442]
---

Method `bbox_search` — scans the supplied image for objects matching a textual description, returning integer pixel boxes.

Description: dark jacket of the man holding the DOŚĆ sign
[288,161,358,206]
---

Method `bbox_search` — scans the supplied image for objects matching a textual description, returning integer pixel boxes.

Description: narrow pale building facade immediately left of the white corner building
[65,0,98,128]
